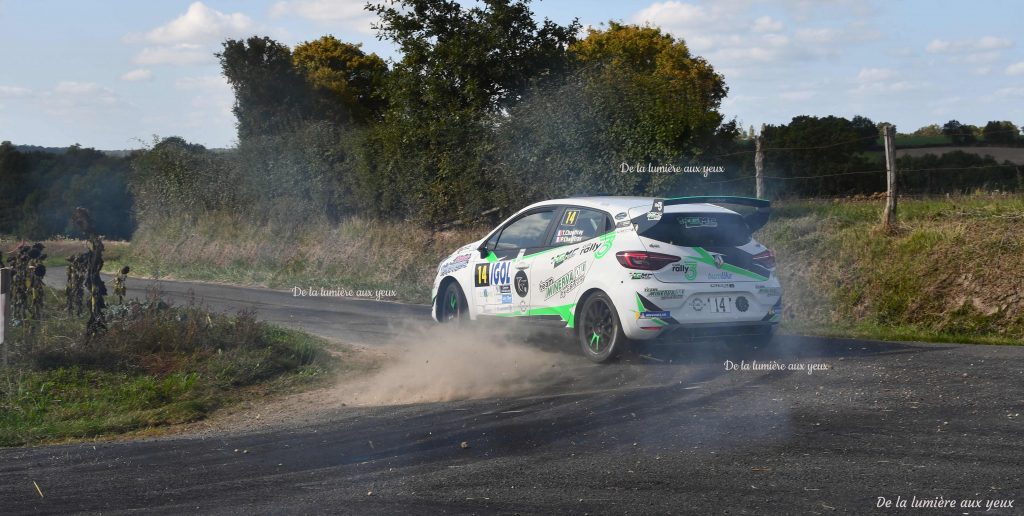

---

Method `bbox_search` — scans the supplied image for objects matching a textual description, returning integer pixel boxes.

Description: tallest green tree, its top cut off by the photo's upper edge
[358,0,580,222]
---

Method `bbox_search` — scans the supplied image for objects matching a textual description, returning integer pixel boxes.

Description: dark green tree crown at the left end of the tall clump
[216,36,310,139]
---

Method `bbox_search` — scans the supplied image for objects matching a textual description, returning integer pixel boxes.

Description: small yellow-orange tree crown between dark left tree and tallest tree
[292,36,388,123]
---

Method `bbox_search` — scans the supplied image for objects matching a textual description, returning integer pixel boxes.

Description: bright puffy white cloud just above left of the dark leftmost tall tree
[136,2,254,45]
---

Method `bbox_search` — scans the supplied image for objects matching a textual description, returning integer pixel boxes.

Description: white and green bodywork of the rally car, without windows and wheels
[432,197,782,339]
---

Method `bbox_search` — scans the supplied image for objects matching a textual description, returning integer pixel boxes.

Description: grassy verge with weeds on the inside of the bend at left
[0,291,338,446]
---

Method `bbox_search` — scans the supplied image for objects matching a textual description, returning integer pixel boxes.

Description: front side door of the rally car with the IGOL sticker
[473,207,557,316]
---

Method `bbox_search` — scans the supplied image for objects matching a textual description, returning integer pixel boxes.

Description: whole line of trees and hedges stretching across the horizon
[0,0,1021,238]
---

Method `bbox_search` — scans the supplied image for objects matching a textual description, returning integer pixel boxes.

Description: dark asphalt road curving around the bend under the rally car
[0,274,1024,514]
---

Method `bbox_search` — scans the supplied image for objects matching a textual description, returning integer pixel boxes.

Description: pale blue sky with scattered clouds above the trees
[0,0,1024,149]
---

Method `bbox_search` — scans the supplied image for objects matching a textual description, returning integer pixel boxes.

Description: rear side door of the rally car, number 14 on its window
[530,206,614,321]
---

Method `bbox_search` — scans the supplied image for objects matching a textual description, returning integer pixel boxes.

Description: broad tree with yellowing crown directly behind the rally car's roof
[493,23,739,204]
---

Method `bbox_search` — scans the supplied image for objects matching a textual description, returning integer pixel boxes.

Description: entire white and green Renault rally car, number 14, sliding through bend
[432,197,782,361]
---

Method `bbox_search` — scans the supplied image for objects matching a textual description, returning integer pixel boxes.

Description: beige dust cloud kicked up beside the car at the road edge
[335,324,586,405]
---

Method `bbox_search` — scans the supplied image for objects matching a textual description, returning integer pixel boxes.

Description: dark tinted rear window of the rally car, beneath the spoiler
[640,213,751,247]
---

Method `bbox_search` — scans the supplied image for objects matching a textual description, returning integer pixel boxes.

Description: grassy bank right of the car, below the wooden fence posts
[758,196,1024,344]
